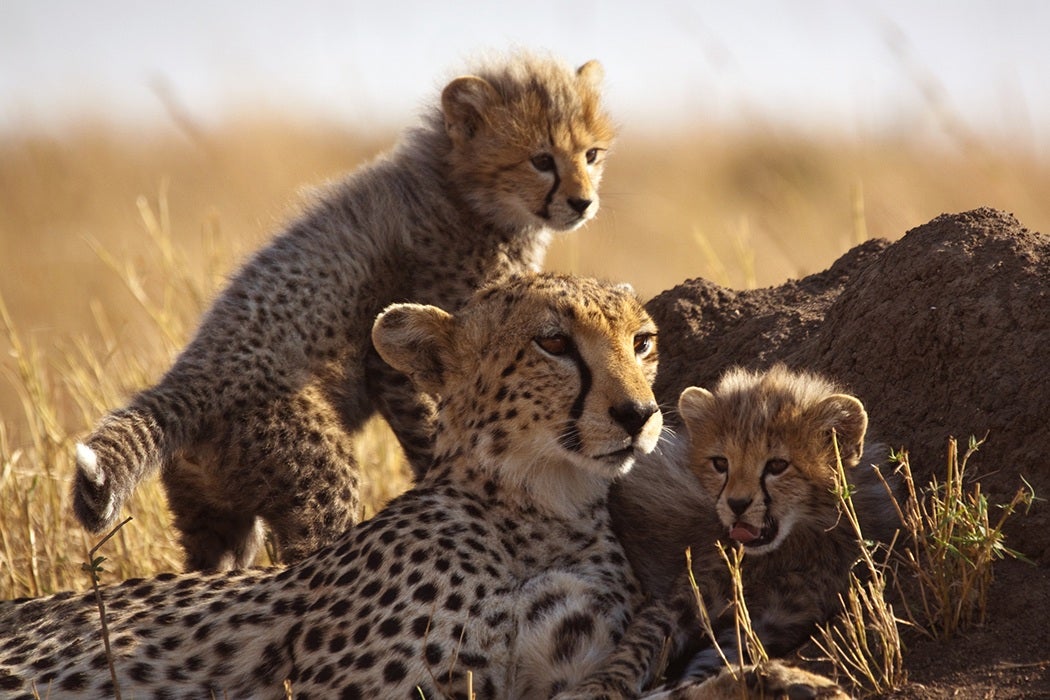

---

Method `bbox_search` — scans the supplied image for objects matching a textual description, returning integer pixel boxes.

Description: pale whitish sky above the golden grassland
[0,0,1050,150]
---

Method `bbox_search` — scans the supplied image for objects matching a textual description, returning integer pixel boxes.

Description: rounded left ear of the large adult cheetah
[372,303,453,394]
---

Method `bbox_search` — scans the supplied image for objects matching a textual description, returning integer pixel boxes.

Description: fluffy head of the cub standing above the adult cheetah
[441,55,613,231]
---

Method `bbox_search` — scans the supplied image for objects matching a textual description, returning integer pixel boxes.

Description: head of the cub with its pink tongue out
[678,365,867,554]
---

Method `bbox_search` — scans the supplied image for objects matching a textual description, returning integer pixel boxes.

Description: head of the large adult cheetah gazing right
[373,274,663,514]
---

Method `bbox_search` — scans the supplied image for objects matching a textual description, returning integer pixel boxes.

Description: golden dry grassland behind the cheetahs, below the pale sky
[0,118,1050,598]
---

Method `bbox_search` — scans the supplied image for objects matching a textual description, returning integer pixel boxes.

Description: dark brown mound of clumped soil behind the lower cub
[648,209,1050,699]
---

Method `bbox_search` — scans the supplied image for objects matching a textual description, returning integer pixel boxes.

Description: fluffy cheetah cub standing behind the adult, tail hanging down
[74,55,613,570]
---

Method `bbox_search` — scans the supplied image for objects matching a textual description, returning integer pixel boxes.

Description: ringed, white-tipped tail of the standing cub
[72,408,165,532]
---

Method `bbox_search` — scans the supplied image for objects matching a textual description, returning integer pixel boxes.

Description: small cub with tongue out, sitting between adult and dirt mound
[562,365,899,697]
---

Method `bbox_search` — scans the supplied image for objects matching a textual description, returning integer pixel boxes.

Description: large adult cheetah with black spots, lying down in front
[0,275,663,700]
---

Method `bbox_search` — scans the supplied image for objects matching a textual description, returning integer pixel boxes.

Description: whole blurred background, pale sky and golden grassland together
[0,0,1050,592]
